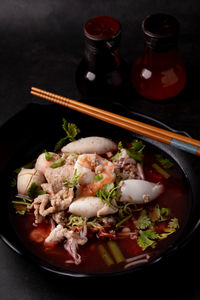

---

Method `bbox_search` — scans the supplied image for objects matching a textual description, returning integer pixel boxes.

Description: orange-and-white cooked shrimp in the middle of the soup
[74,153,115,197]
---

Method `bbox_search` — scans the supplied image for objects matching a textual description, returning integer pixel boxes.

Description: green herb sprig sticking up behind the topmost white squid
[54,118,80,151]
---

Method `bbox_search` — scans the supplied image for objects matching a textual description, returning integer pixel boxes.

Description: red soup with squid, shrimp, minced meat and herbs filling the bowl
[12,122,188,273]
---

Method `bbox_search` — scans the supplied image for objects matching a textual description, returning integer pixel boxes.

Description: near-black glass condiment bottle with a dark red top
[76,16,129,96]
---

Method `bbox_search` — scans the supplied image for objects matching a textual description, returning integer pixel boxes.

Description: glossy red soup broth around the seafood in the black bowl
[13,149,189,273]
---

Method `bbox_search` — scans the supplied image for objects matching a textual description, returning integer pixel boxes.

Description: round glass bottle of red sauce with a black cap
[131,14,186,100]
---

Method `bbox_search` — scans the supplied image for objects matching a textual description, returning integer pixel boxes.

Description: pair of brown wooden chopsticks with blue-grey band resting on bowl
[31,87,200,156]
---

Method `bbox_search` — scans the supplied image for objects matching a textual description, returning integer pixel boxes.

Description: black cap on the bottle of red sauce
[142,13,179,52]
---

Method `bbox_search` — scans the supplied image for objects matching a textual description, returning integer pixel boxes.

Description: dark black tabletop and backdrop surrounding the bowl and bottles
[0,0,200,300]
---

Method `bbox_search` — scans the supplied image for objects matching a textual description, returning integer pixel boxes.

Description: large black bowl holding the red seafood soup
[0,104,200,277]
